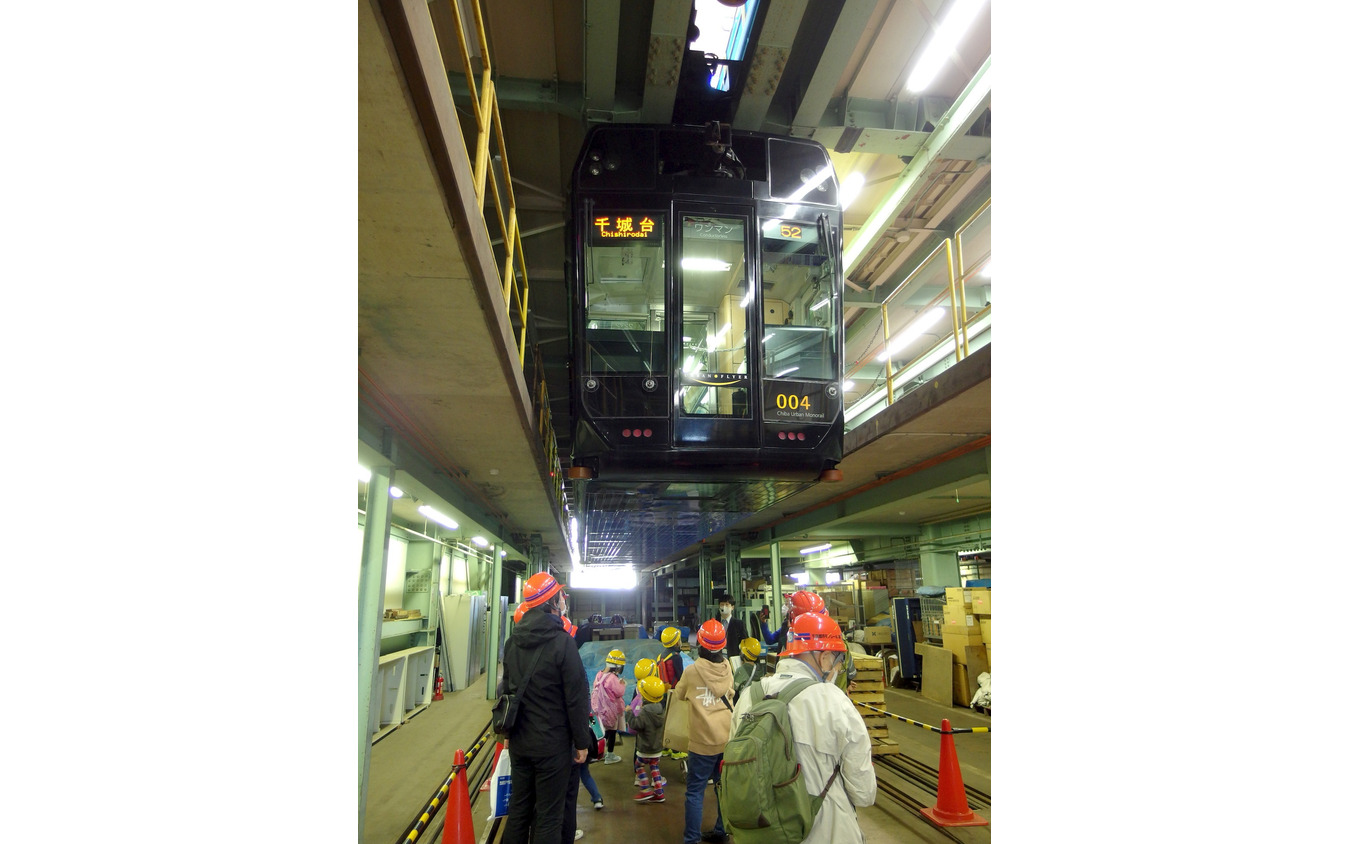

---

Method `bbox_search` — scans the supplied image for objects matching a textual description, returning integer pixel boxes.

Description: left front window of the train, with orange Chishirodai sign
[583,209,667,374]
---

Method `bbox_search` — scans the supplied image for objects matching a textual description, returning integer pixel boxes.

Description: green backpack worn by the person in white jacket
[718,678,840,844]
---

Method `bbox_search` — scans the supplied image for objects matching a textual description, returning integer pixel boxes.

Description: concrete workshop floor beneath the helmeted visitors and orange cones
[360,679,992,844]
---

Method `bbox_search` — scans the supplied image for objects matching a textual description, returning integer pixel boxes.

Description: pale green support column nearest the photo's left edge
[356,463,394,840]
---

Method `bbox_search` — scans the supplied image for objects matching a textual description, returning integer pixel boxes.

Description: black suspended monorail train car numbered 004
[567,123,844,482]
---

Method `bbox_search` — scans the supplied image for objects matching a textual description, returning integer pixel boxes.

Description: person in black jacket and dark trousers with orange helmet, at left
[501,571,591,844]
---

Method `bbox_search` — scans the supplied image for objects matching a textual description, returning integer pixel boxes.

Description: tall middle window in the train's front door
[678,215,753,417]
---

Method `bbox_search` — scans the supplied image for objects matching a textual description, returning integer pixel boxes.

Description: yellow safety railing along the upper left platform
[446,0,529,366]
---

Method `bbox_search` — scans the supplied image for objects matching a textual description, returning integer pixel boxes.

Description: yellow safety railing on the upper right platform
[855,200,991,415]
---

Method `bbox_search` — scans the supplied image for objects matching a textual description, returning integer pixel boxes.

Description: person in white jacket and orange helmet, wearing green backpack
[732,613,876,844]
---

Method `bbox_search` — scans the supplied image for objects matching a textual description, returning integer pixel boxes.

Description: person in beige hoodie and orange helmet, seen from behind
[671,621,733,844]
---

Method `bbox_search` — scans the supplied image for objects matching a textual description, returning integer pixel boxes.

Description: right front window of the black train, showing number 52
[761,220,838,379]
